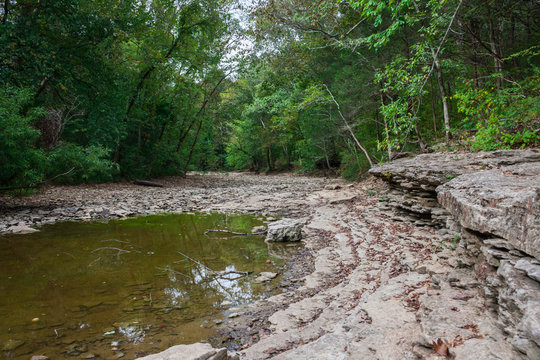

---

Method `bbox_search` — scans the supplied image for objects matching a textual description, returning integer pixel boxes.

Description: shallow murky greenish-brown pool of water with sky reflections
[0,214,292,359]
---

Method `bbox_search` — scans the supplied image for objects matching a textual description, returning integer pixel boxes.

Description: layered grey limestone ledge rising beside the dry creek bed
[370,149,540,359]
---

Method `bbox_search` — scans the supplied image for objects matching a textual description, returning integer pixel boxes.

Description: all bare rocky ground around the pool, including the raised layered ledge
[0,150,540,360]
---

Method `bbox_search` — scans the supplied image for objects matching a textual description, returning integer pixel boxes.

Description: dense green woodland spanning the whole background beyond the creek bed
[0,0,540,191]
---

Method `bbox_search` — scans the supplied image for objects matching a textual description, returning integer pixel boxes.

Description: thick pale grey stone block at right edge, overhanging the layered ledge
[437,161,540,259]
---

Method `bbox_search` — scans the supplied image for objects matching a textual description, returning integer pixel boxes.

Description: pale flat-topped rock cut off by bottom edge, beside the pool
[139,343,238,360]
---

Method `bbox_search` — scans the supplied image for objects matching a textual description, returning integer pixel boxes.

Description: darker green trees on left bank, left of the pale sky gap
[0,0,238,187]
